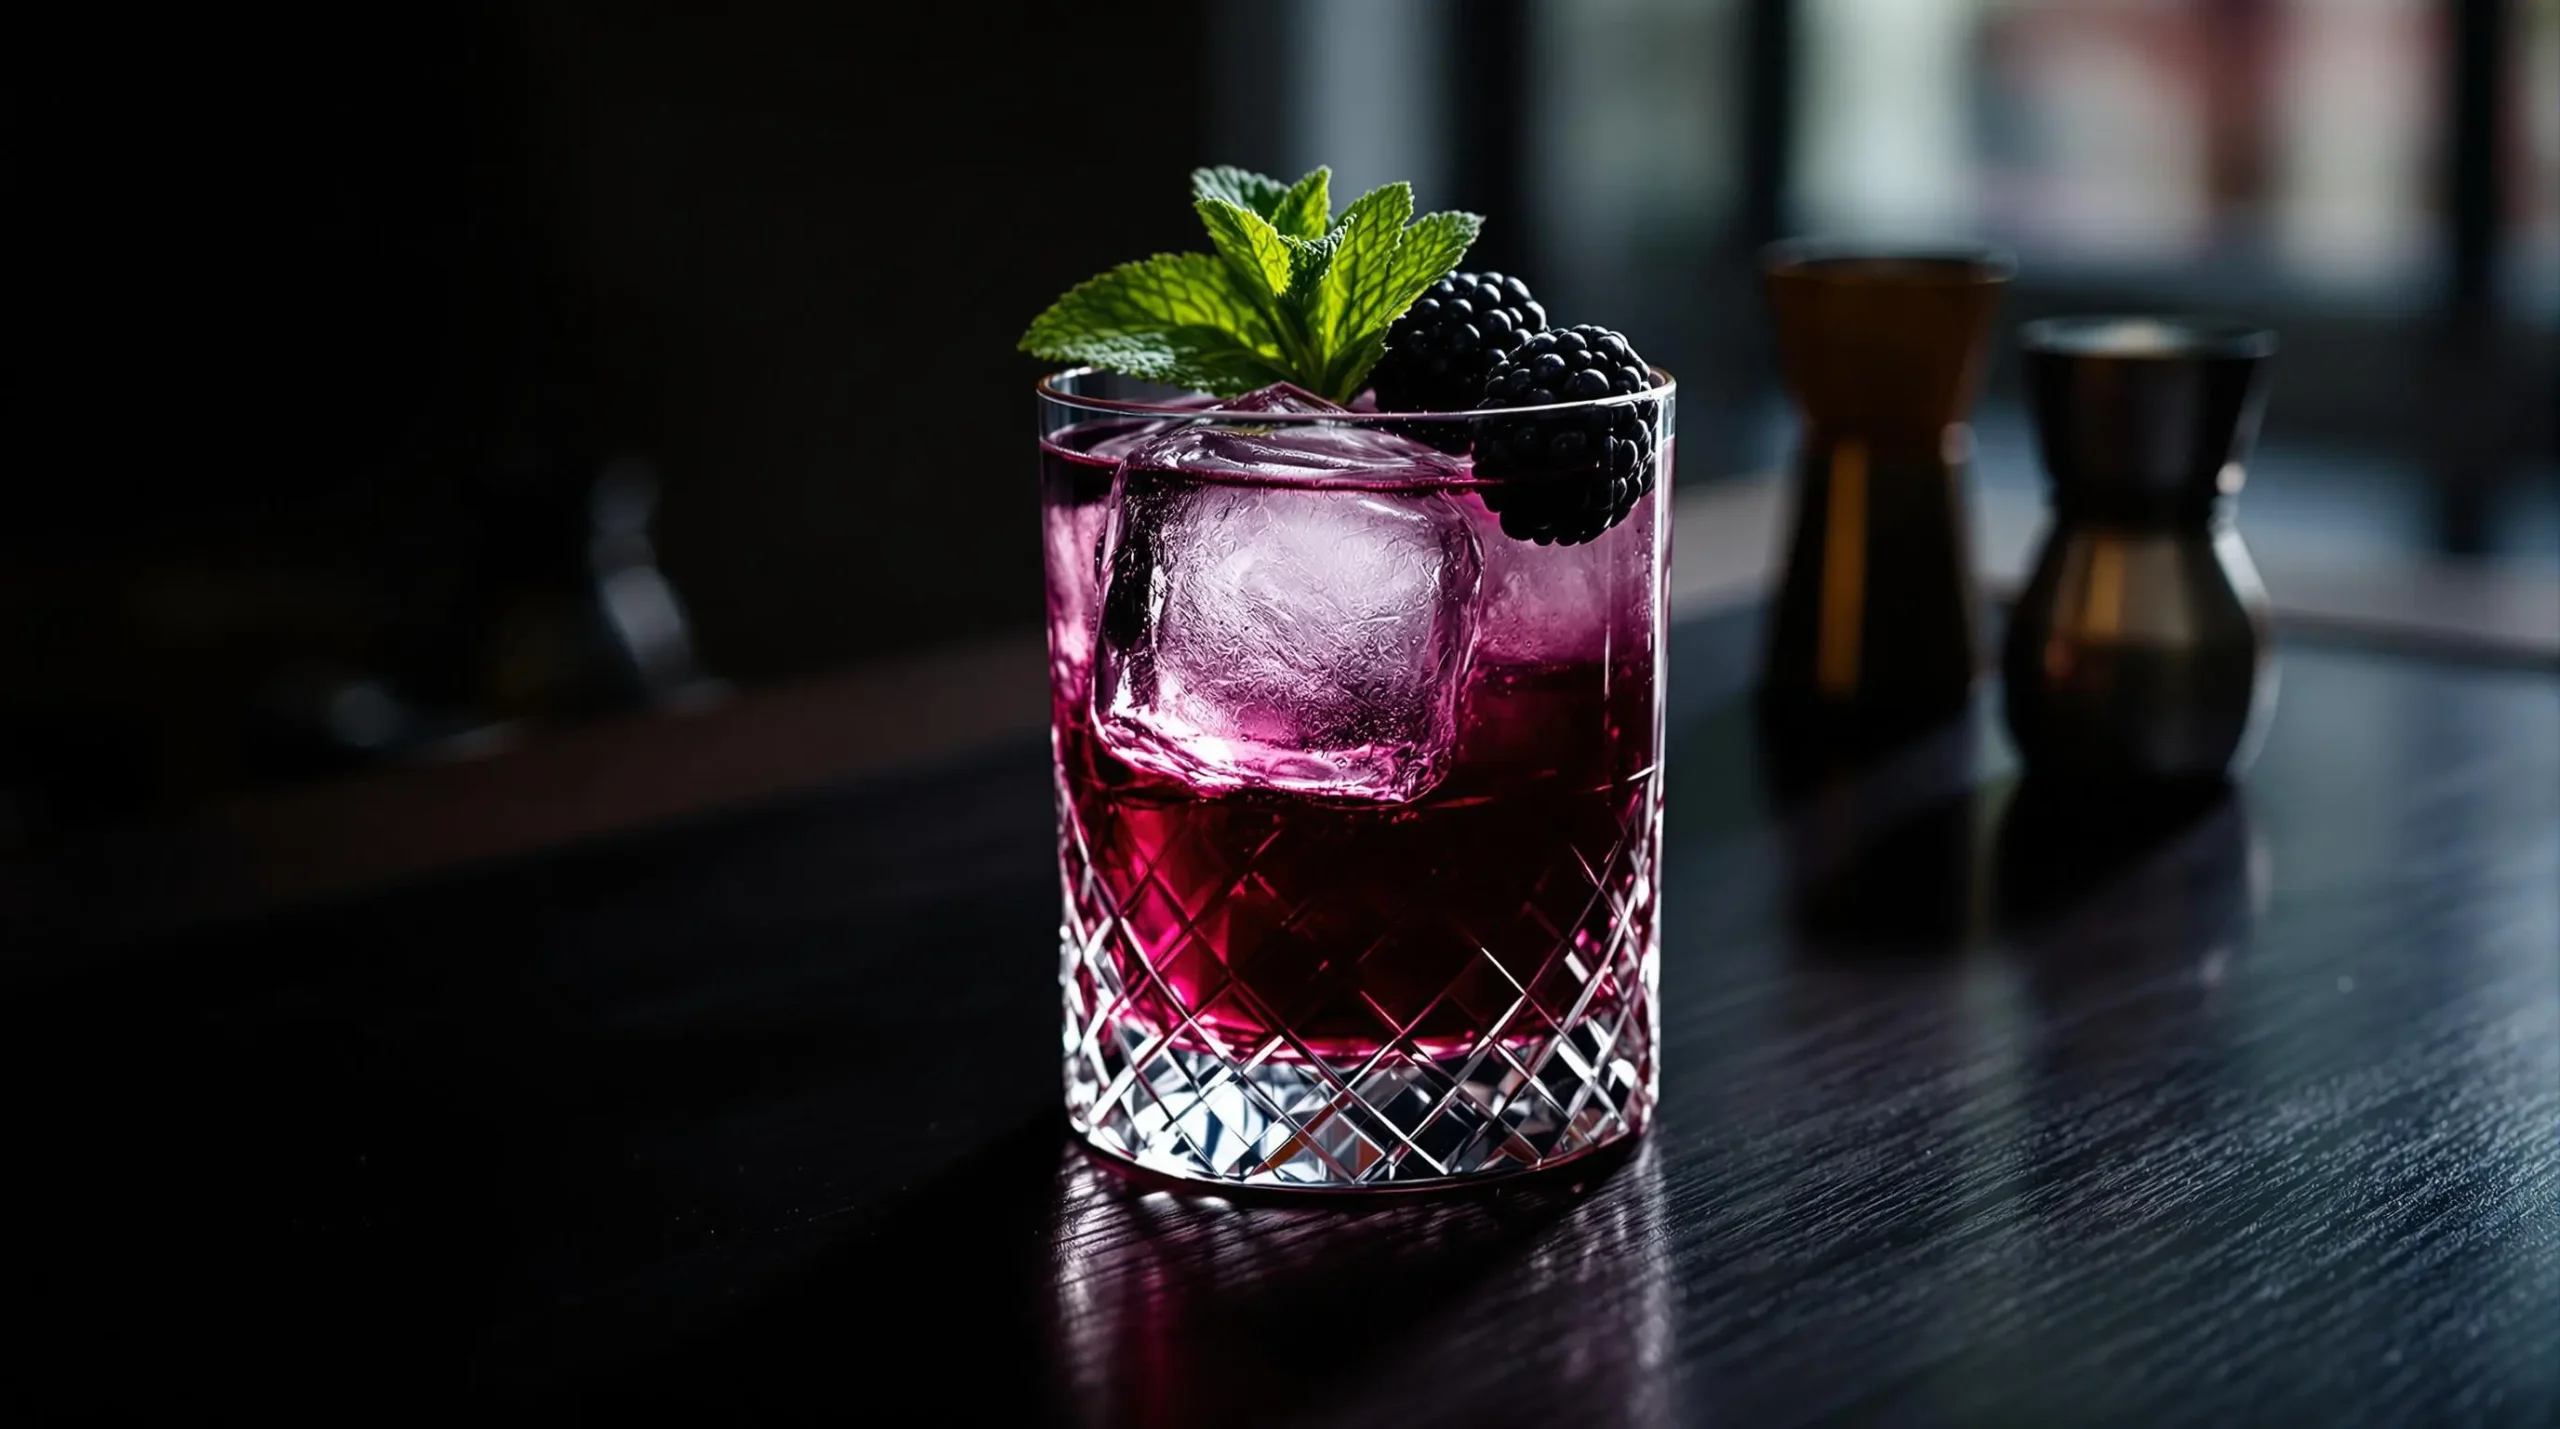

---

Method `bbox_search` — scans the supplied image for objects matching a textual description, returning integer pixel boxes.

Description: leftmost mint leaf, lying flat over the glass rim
[1021,254,1295,397]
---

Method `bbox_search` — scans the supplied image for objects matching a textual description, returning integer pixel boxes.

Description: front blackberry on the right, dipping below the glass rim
[1475,325,1659,545]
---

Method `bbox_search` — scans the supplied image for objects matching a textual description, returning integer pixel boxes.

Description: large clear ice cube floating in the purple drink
[1093,392,1482,802]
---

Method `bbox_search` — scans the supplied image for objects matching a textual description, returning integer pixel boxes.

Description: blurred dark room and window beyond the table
[0,0,2560,855]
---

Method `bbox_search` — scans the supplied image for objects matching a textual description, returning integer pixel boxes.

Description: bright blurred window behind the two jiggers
[1229,0,2560,566]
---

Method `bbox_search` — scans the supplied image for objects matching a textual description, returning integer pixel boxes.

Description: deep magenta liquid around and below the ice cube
[1042,430,1659,1065]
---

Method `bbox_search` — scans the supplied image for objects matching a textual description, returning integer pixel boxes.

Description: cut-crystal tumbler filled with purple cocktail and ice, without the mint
[1039,371,1672,1188]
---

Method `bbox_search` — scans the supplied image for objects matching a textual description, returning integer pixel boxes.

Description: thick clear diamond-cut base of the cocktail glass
[1068,978,1656,1191]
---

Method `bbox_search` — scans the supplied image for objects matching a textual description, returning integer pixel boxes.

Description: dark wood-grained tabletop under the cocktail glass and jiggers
[0,615,2560,1426]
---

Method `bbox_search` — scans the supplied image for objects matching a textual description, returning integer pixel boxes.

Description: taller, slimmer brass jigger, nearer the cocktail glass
[1759,241,2015,738]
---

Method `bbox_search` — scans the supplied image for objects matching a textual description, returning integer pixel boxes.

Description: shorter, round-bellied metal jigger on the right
[2002,318,2276,789]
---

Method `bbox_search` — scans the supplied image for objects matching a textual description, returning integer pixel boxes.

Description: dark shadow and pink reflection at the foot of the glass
[509,1117,1674,1429]
